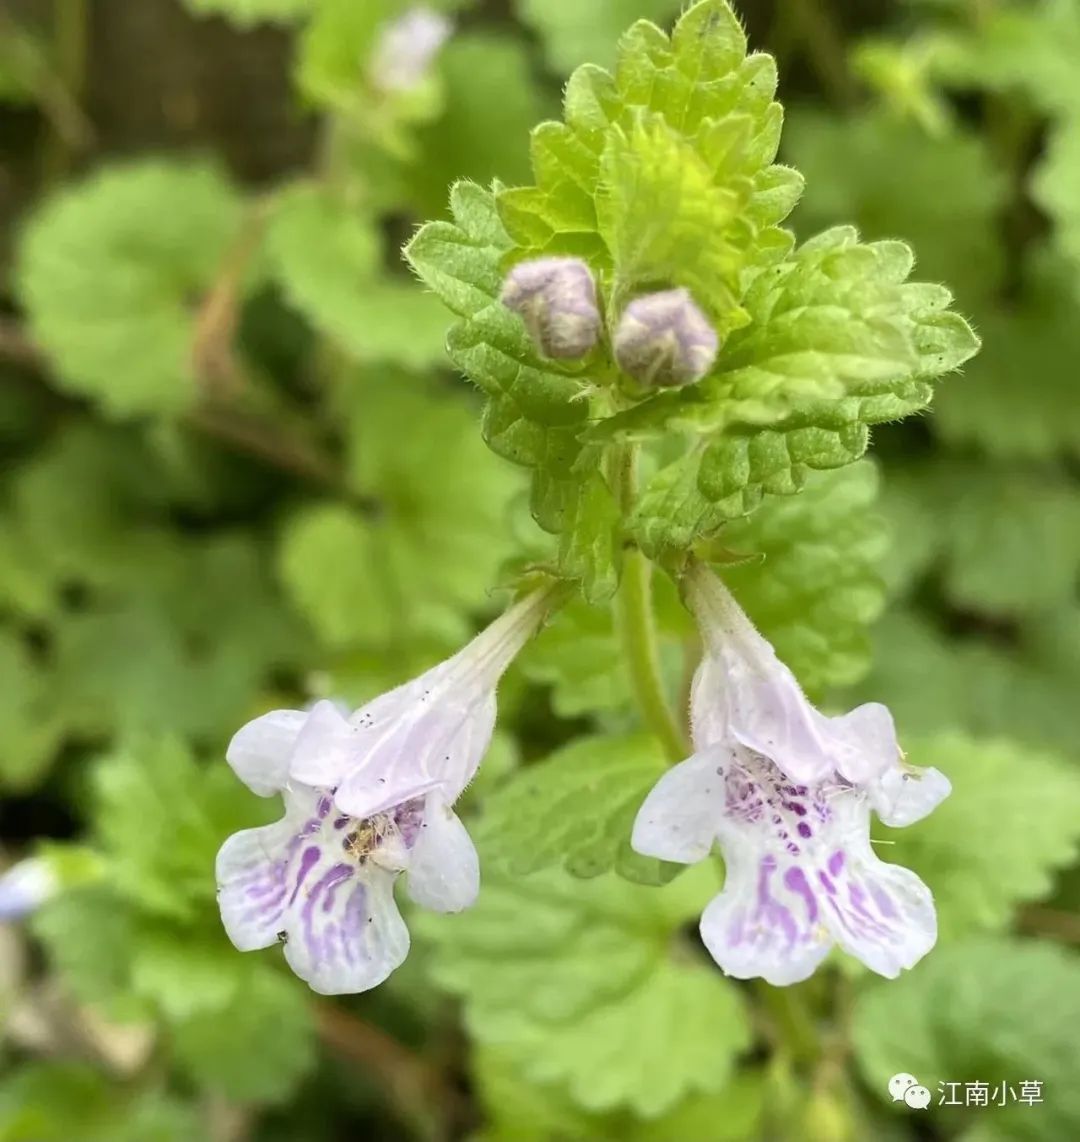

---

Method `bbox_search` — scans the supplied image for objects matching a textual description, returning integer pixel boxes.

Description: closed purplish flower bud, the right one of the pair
[614,289,720,388]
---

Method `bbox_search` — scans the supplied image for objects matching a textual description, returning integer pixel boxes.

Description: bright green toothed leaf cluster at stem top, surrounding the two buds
[406,0,978,600]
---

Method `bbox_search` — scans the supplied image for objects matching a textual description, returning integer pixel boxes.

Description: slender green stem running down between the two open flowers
[614,444,687,763]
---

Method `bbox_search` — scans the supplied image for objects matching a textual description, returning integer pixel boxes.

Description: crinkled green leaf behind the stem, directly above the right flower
[720,461,890,693]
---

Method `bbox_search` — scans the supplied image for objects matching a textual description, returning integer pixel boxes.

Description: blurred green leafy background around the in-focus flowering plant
[0,0,1080,1142]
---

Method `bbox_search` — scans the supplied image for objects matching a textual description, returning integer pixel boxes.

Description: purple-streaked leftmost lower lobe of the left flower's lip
[216,799,311,951]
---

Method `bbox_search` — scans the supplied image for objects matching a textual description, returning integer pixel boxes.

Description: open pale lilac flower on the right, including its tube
[632,566,950,984]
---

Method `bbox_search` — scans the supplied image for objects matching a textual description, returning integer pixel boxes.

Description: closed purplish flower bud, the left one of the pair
[502,258,601,357]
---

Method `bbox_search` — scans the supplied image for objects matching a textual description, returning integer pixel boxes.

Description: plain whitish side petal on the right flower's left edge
[630,746,730,864]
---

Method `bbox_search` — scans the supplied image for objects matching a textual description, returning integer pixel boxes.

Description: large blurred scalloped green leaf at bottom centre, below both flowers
[422,864,750,1117]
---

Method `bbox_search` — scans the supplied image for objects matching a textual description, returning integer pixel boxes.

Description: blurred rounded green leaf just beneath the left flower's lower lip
[172,967,315,1103]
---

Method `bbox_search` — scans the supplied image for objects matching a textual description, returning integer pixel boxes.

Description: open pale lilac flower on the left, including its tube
[217,590,553,995]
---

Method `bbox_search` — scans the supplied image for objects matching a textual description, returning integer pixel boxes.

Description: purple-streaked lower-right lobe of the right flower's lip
[821,843,937,979]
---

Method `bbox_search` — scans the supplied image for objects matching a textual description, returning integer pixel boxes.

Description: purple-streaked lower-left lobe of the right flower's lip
[701,845,832,987]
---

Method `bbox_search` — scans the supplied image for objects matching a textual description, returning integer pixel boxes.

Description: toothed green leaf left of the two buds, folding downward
[405,183,616,598]
